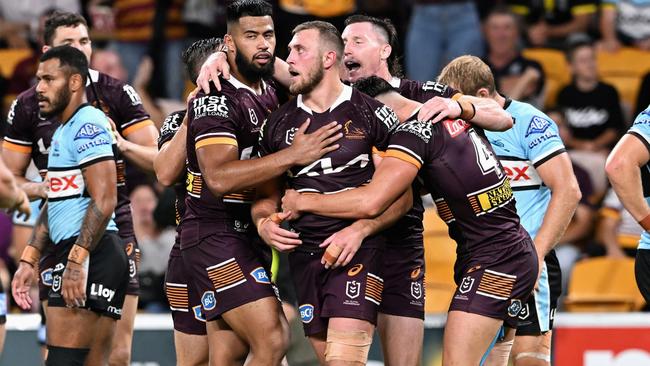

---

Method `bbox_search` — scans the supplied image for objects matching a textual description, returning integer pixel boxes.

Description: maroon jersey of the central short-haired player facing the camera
[259,86,398,251]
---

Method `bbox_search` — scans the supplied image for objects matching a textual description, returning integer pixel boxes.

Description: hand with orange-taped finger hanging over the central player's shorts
[319,225,365,269]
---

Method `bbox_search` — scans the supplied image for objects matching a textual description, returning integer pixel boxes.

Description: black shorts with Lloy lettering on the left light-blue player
[48,232,129,319]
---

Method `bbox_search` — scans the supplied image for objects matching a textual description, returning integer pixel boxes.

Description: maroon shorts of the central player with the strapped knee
[289,248,384,336]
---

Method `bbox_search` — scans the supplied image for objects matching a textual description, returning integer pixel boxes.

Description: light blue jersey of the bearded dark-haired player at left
[47,104,117,244]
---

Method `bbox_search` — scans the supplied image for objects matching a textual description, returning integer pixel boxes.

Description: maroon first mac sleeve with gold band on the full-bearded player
[189,94,238,150]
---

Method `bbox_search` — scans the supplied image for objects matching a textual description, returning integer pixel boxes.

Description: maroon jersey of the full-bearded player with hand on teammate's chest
[181,76,278,249]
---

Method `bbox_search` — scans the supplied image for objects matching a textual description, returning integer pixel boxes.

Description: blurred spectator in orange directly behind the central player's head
[272,0,357,59]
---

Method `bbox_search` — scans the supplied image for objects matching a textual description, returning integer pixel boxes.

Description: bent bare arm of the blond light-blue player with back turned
[535,152,582,260]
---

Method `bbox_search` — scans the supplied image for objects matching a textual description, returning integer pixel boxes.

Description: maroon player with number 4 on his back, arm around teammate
[283,77,537,365]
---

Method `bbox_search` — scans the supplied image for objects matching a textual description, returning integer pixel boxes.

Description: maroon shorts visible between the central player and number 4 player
[379,246,425,320]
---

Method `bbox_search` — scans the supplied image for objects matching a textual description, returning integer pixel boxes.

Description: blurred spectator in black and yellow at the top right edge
[508,0,598,48]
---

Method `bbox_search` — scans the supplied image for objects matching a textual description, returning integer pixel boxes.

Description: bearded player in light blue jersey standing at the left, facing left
[12,45,129,366]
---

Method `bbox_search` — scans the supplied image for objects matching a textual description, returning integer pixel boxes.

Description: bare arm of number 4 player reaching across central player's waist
[283,156,419,219]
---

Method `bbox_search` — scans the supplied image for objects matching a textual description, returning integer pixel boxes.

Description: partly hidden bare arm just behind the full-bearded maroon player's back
[153,114,187,186]
